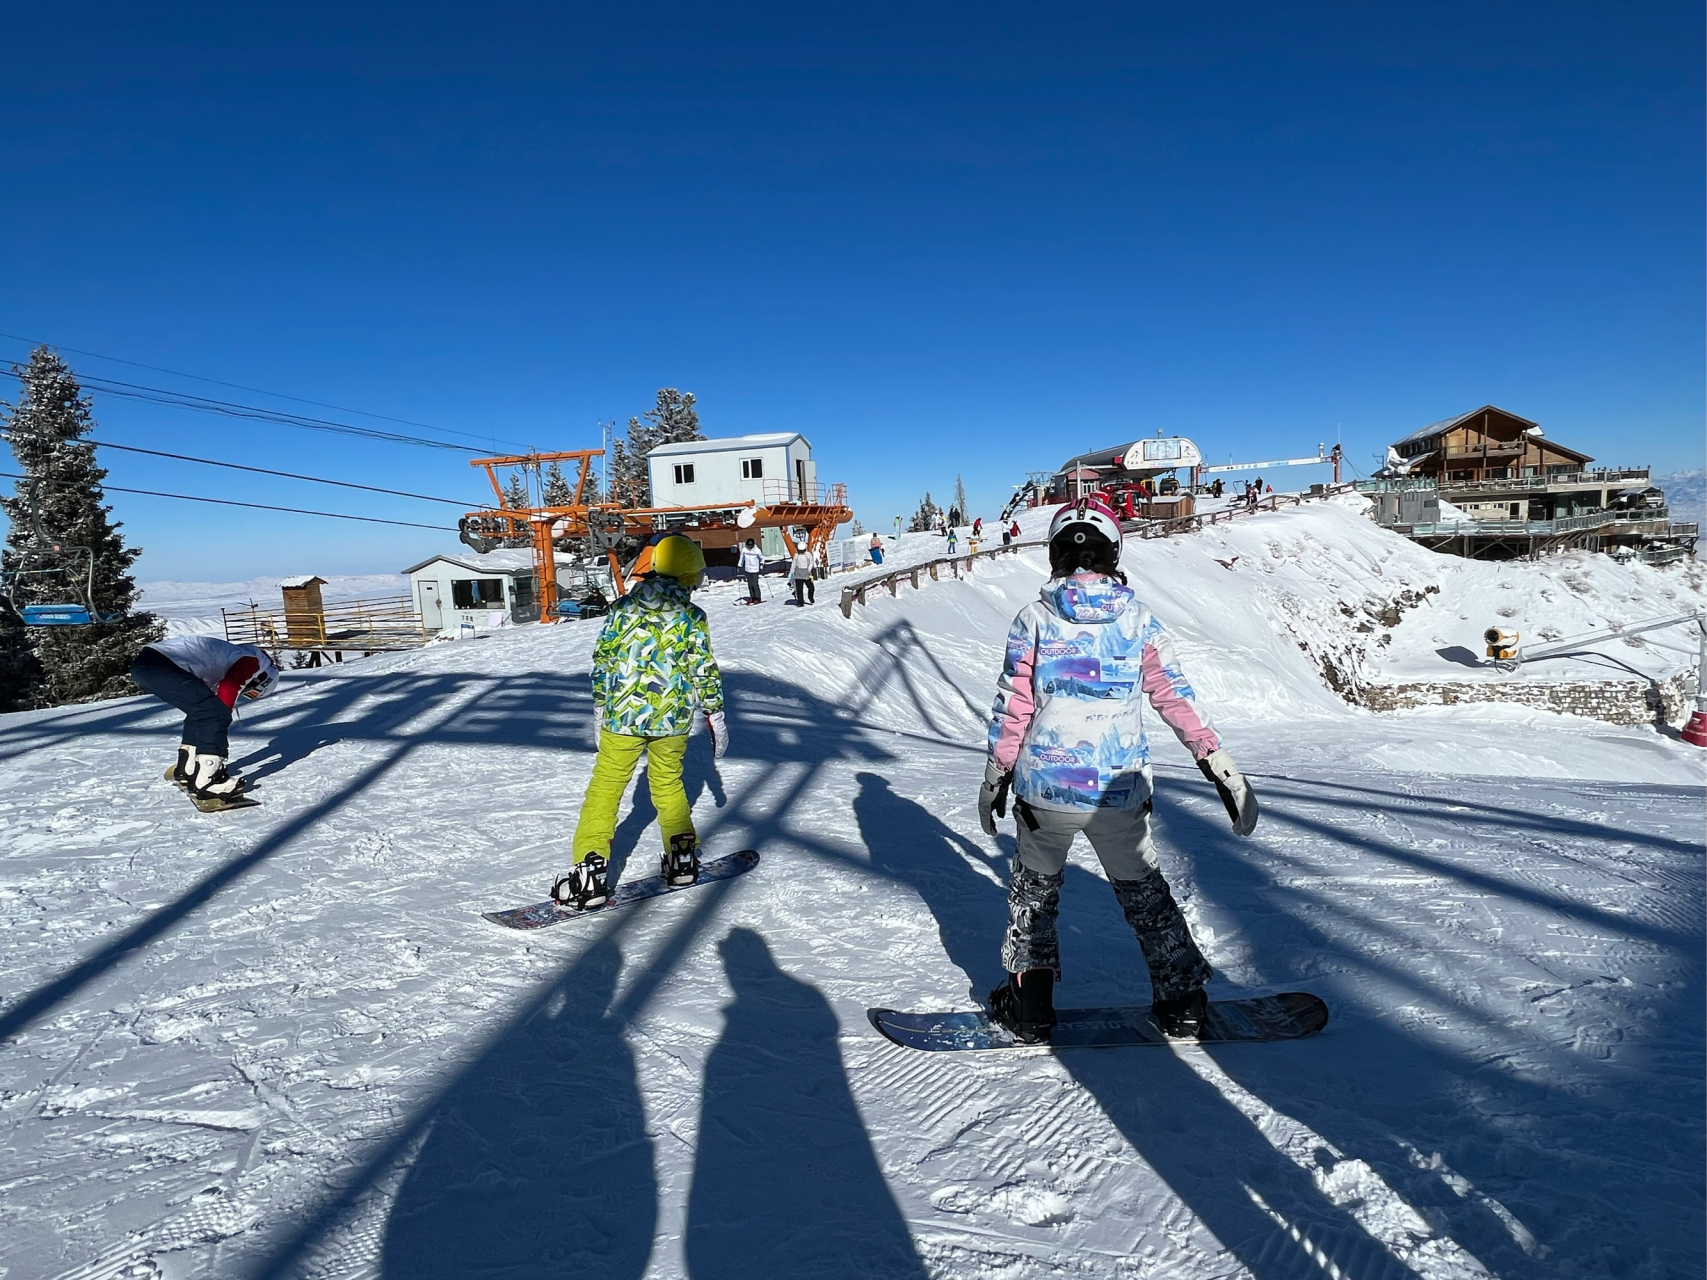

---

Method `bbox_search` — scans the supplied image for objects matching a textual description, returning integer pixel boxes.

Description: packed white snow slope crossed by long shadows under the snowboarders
[0,505,1704,1280]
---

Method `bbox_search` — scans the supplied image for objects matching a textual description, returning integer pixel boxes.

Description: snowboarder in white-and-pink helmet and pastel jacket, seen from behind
[978,498,1256,1043]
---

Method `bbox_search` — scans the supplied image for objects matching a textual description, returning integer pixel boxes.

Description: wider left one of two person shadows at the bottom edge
[379,939,657,1280]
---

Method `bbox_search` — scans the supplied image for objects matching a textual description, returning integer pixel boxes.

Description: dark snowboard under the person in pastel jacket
[865,992,1328,1053]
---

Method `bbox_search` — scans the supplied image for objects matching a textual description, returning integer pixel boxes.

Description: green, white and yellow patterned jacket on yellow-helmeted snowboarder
[592,577,724,737]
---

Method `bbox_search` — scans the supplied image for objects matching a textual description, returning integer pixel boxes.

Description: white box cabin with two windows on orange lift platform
[645,432,821,507]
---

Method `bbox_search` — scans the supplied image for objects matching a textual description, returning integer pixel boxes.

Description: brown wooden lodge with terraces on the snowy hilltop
[1367,404,1697,561]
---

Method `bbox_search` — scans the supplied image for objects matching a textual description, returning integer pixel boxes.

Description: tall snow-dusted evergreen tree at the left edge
[0,346,166,708]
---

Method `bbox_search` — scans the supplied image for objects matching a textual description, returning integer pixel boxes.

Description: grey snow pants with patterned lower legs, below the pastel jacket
[1002,802,1210,1000]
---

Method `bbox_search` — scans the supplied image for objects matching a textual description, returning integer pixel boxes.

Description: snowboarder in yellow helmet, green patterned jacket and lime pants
[551,534,729,910]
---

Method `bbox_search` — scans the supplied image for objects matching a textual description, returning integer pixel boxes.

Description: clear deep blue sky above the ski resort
[0,3,1707,580]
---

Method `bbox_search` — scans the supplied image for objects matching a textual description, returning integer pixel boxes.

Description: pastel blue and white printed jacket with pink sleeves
[990,573,1221,809]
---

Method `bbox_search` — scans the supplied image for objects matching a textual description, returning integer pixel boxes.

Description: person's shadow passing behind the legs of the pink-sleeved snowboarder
[855,773,1413,1280]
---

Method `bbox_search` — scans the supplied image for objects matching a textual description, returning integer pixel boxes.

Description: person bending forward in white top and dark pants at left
[130,635,278,812]
